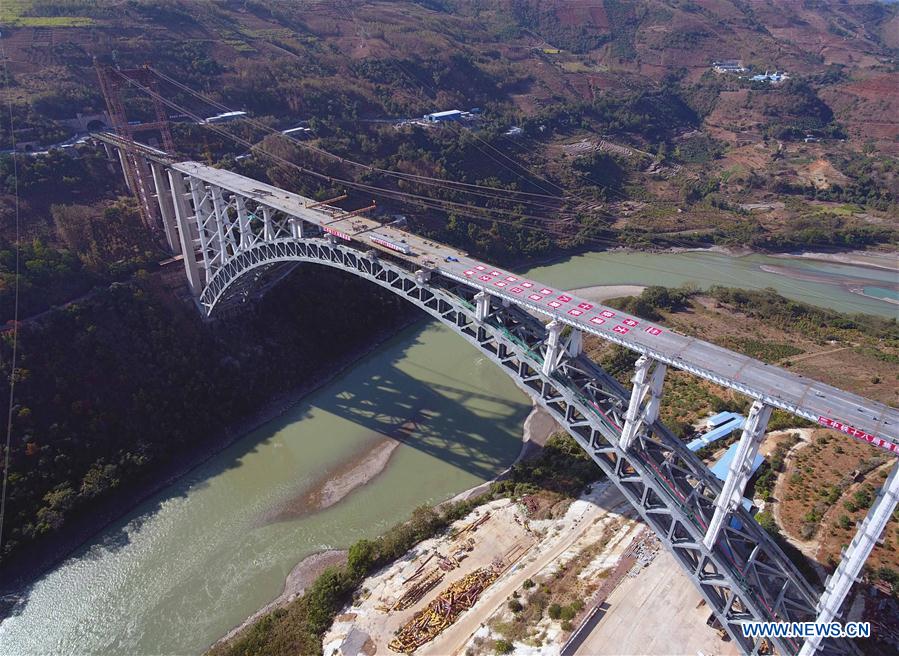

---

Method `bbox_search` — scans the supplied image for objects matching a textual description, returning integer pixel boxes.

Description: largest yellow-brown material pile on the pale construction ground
[388,567,501,654]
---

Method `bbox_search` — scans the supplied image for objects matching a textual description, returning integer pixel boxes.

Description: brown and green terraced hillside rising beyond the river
[0,0,899,261]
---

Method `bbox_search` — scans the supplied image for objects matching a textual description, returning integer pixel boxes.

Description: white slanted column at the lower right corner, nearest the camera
[799,458,899,656]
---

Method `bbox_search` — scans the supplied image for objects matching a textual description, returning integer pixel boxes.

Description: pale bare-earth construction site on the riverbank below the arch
[323,485,737,656]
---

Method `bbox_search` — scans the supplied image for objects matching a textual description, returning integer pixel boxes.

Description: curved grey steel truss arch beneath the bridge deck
[200,237,855,654]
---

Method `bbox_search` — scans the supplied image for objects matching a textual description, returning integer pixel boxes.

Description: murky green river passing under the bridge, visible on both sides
[0,253,896,656]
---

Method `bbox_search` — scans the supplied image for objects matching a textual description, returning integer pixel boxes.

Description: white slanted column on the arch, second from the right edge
[702,401,772,549]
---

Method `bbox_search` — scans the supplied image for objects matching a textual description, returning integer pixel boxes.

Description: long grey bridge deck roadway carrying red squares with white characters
[172,162,899,454]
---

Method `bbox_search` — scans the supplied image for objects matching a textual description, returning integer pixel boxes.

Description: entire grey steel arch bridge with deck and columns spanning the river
[95,136,899,654]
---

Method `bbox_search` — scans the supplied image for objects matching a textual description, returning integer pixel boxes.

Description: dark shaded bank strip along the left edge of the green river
[0,314,422,596]
